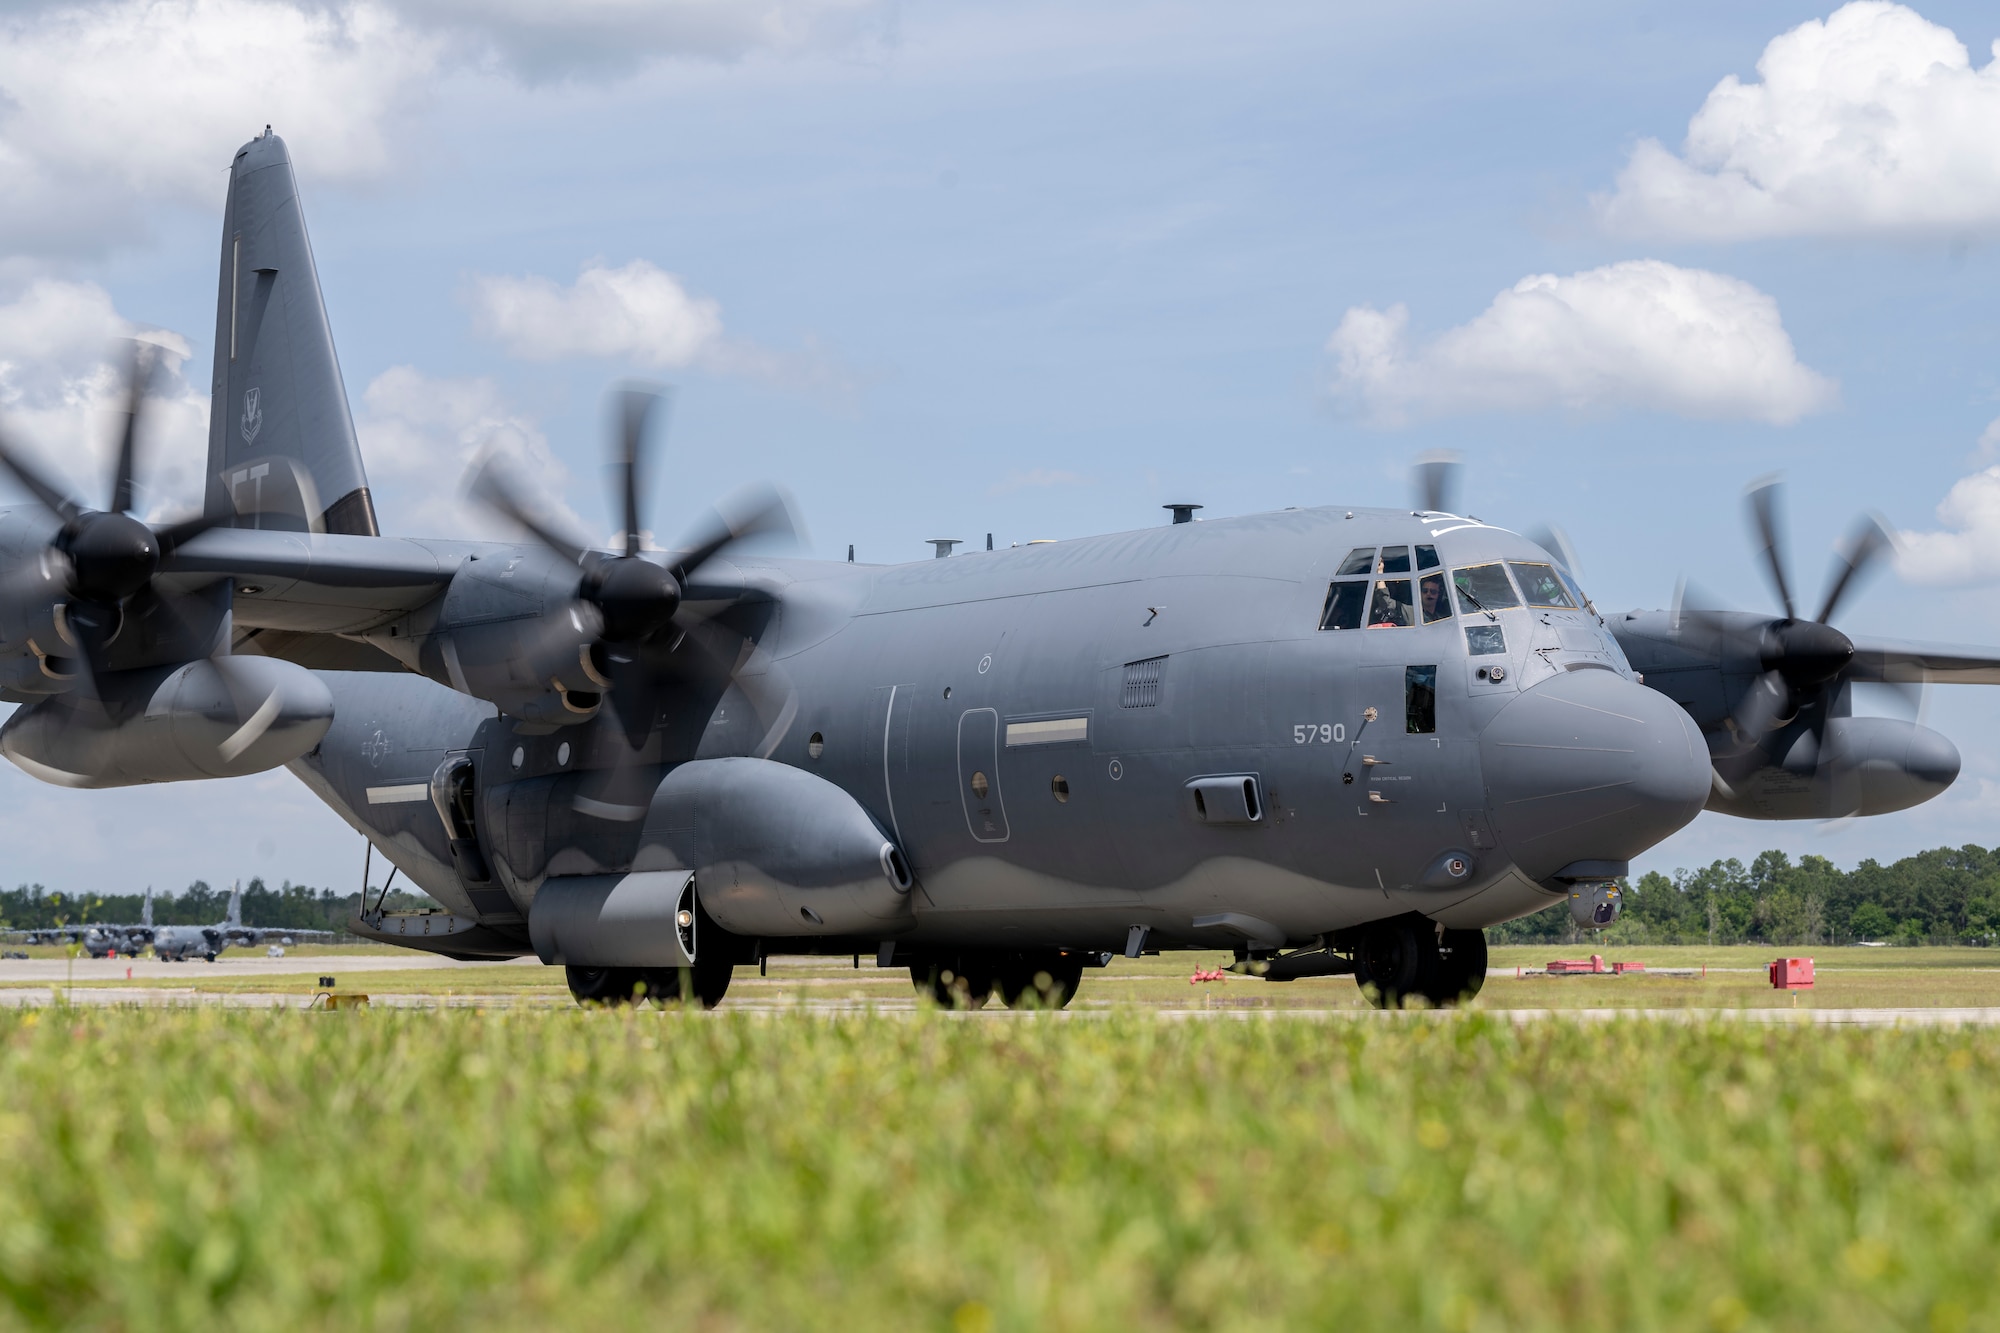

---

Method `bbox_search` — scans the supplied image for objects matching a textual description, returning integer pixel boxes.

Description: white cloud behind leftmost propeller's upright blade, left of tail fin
[0,278,208,518]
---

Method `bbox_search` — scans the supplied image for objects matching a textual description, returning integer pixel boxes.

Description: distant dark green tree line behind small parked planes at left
[0,879,436,931]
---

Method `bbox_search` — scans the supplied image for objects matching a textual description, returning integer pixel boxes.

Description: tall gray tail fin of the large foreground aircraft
[204,126,380,536]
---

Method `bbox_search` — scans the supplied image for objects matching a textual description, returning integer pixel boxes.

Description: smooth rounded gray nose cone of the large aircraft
[1480,671,1710,881]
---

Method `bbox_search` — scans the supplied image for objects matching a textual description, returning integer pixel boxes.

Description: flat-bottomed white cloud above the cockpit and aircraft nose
[1326,260,1838,424]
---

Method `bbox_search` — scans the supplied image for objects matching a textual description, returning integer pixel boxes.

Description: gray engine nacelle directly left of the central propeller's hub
[420,552,610,725]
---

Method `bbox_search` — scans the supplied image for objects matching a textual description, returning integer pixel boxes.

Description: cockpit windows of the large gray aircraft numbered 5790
[1320,544,1590,656]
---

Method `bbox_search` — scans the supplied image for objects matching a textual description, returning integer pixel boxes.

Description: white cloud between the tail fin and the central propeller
[354,366,584,540]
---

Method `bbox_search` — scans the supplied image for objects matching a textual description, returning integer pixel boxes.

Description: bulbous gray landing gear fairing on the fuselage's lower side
[632,759,916,939]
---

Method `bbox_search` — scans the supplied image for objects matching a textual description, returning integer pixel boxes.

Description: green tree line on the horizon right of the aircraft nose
[1488,845,2000,945]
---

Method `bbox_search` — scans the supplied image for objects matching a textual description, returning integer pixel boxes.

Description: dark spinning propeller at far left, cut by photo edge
[0,342,224,679]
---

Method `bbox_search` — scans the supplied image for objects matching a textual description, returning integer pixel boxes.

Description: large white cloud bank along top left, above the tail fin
[0,0,890,260]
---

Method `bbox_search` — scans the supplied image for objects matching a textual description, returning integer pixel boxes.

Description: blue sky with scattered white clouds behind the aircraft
[0,0,2000,891]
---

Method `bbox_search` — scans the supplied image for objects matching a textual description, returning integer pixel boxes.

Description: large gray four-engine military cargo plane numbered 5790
[0,130,1992,1005]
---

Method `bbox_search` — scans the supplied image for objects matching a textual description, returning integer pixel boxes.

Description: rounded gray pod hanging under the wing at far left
[0,656,334,787]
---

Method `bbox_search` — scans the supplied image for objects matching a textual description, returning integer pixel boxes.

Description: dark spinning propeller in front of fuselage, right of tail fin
[468,386,798,819]
